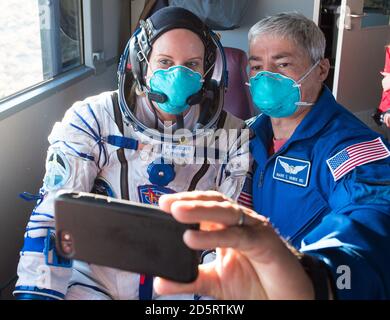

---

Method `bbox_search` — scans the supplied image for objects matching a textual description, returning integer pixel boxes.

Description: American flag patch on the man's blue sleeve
[326,138,390,181]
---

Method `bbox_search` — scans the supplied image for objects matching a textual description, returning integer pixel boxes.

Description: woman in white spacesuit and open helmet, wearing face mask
[14,7,249,299]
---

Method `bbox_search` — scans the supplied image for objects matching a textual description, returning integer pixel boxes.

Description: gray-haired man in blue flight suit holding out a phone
[155,13,390,299]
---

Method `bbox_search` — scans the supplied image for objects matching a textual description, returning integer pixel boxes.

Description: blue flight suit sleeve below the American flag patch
[301,160,390,299]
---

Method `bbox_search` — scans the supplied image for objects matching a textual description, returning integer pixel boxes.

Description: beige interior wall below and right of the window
[0,0,130,299]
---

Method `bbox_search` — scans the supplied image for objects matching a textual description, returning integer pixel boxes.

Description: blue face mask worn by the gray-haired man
[249,61,320,118]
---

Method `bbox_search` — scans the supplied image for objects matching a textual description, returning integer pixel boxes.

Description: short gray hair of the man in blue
[248,12,326,63]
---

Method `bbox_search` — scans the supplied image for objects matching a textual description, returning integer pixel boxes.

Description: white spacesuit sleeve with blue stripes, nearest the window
[14,103,107,299]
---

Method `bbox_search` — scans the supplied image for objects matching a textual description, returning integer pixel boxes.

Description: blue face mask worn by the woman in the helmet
[149,66,203,115]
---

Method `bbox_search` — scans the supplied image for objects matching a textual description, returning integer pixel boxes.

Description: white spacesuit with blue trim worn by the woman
[14,9,250,299]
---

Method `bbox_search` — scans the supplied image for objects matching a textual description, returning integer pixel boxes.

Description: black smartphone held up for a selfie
[55,192,199,283]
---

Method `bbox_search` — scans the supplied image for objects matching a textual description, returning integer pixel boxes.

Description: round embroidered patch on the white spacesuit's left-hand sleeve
[43,149,70,191]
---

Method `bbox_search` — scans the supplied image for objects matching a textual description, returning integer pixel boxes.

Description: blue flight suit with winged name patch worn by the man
[250,87,390,299]
